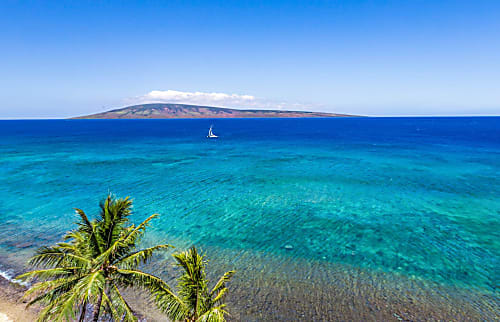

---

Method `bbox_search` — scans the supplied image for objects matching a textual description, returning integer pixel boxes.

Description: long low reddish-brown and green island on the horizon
[74,104,353,119]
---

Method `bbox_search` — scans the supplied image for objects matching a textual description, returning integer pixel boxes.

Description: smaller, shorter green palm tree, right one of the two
[155,246,235,322]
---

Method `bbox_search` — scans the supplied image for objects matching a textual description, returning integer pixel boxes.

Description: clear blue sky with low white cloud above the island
[0,0,500,118]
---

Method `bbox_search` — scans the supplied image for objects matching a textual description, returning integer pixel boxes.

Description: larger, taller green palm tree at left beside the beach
[18,195,175,321]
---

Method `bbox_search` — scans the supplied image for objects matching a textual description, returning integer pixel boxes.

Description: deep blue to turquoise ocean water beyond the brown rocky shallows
[0,118,500,318]
